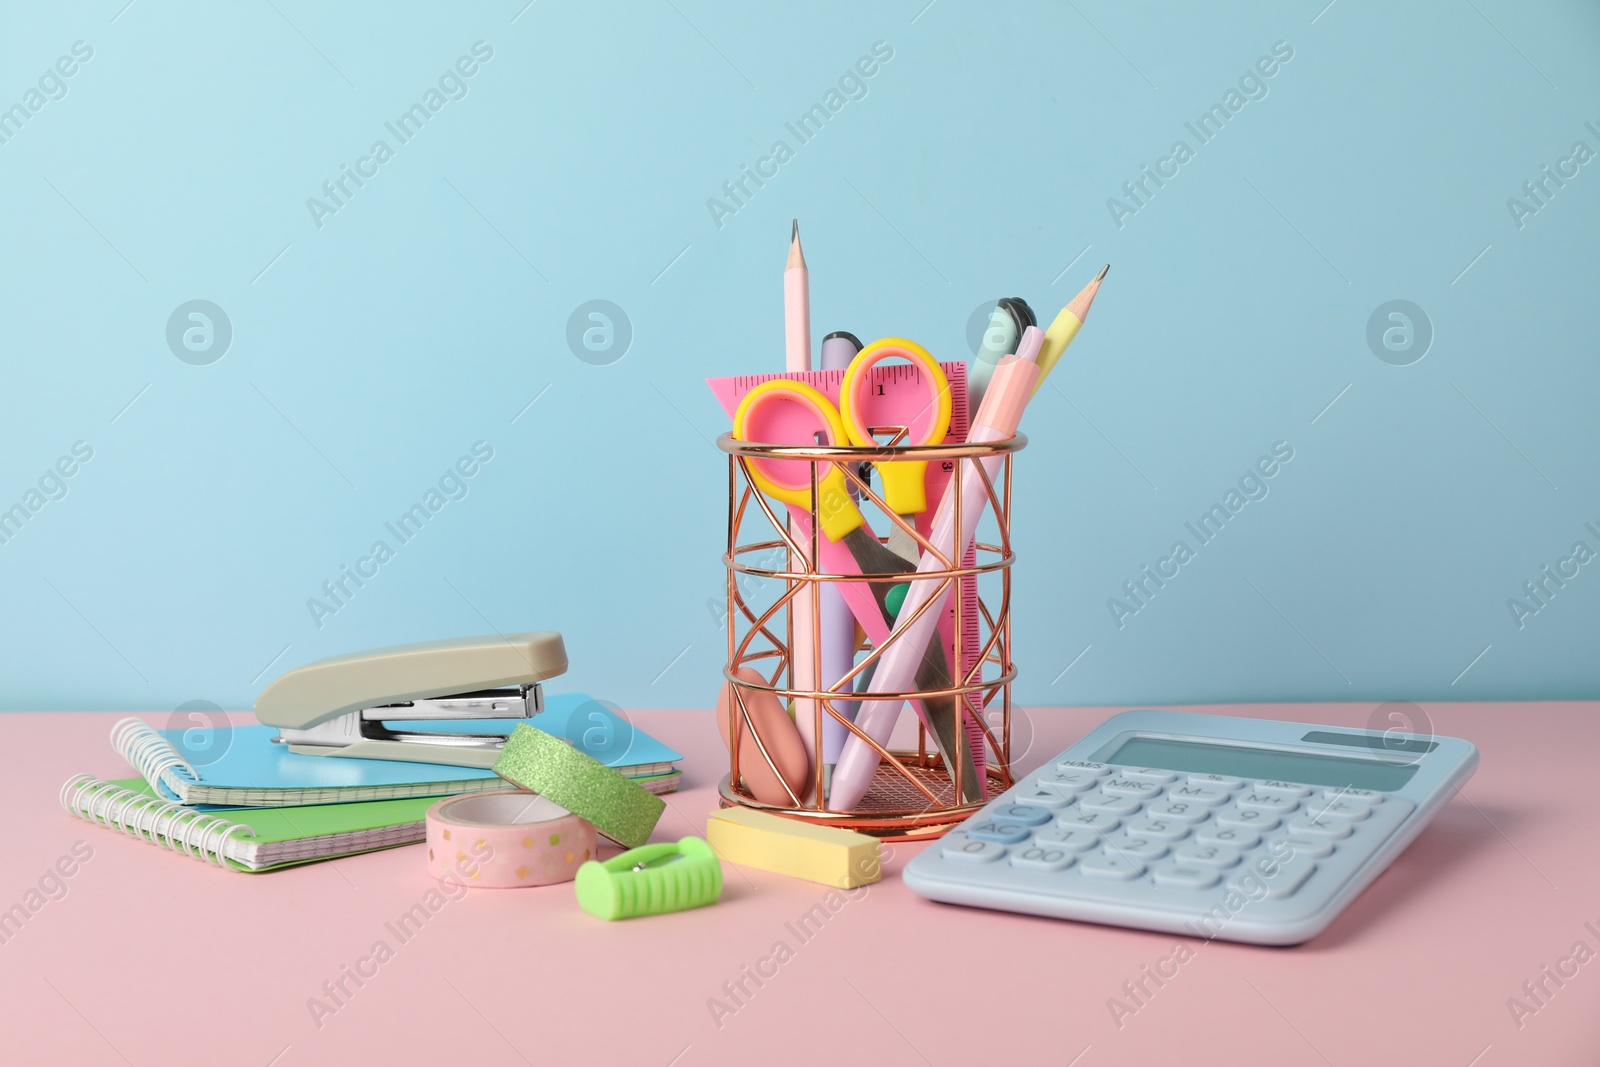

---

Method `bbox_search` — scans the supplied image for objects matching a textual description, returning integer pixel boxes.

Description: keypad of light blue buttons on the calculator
[939,760,1414,915]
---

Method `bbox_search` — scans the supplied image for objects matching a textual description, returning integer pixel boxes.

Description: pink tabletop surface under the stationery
[0,702,1600,1067]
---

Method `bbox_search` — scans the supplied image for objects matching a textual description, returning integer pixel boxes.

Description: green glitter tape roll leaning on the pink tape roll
[494,723,667,848]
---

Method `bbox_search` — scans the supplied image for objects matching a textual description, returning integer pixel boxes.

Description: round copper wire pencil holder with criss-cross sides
[717,434,1027,840]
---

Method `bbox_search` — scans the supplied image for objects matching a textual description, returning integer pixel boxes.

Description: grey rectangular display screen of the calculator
[1104,736,1416,792]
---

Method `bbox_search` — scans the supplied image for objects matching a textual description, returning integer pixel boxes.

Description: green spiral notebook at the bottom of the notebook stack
[61,774,438,872]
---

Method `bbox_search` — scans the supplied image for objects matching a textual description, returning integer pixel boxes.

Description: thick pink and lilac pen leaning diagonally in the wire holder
[827,326,1045,811]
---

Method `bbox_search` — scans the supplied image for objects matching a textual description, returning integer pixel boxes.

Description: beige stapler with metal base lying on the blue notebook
[256,630,566,768]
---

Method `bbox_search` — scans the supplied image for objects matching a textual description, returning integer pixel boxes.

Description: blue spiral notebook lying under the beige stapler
[110,693,683,808]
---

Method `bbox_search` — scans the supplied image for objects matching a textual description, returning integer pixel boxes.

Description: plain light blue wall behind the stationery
[0,0,1600,709]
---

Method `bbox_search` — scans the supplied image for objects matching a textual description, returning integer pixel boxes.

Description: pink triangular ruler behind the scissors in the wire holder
[706,363,989,797]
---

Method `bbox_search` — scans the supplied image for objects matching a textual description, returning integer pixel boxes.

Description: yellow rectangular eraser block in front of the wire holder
[706,808,883,889]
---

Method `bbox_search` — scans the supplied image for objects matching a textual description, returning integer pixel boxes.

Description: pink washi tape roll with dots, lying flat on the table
[427,789,598,889]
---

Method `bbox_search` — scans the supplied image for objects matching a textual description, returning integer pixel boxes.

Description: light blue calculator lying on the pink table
[904,710,1478,945]
